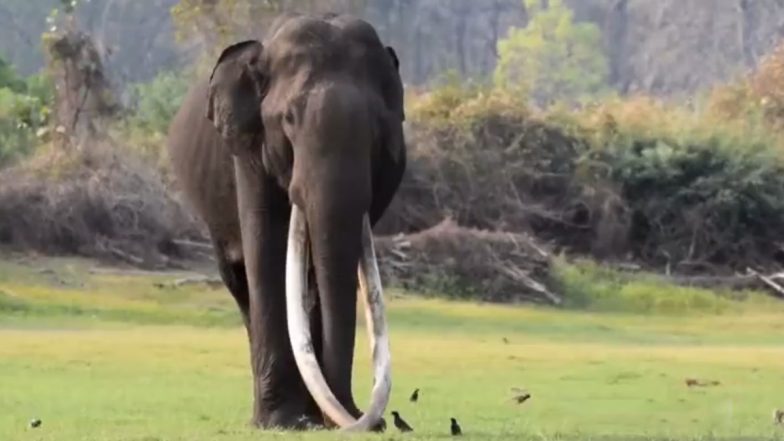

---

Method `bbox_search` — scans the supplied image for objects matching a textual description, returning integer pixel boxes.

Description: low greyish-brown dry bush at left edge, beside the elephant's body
[0,145,202,267]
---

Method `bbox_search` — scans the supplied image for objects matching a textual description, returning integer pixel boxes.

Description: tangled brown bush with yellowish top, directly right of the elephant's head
[377,87,627,260]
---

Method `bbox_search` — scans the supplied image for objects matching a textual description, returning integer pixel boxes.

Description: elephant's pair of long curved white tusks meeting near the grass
[286,205,392,431]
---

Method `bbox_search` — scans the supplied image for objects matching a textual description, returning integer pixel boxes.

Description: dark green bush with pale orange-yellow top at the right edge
[556,97,784,269]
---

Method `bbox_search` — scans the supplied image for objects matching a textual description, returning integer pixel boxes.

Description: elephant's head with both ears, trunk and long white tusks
[202,16,405,428]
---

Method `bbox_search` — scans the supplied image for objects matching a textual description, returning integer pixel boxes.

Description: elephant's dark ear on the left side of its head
[206,40,266,154]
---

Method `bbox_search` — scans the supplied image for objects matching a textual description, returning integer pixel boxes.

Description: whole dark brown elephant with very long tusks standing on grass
[167,14,406,431]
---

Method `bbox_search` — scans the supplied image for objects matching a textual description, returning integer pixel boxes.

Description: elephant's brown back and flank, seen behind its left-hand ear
[167,81,239,248]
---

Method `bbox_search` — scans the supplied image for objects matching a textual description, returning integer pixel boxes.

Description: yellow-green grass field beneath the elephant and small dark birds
[0,254,784,441]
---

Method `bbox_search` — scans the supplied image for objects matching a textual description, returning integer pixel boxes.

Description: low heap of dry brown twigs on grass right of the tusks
[376,219,561,304]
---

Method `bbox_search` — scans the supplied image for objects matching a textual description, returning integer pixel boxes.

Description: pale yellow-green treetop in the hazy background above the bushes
[494,0,608,104]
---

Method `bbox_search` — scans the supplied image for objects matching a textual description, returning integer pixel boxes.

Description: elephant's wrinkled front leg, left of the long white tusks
[235,158,321,428]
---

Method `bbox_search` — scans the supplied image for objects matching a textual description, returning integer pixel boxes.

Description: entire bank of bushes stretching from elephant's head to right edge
[378,86,784,273]
